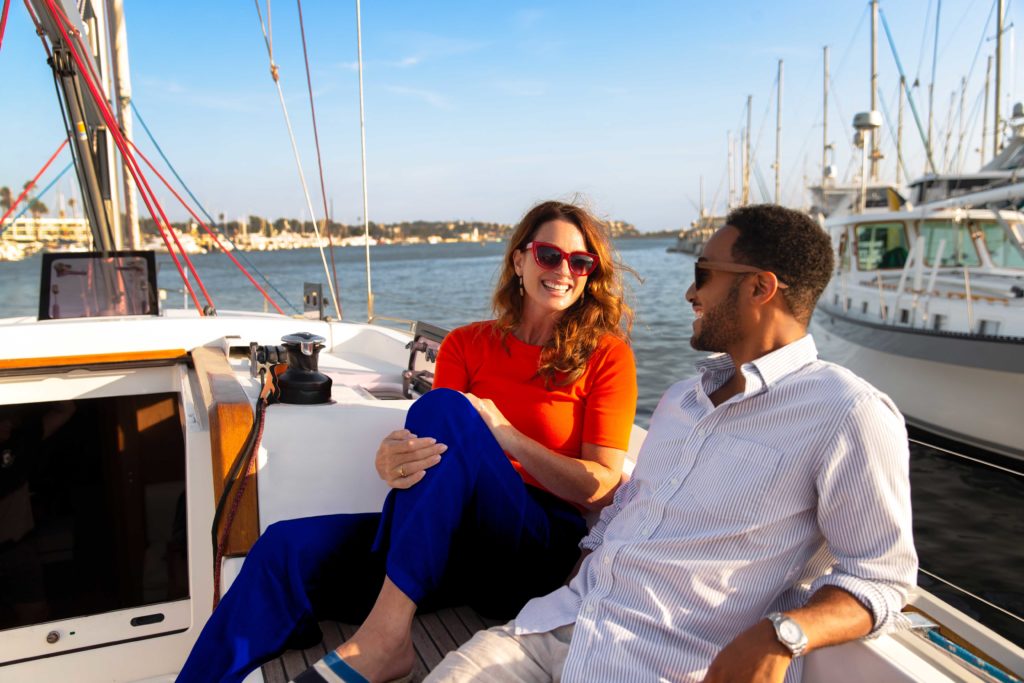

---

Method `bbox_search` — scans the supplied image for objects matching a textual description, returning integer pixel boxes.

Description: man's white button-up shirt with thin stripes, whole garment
[515,335,918,682]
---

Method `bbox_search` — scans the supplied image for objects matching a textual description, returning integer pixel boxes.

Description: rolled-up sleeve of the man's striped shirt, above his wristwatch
[811,394,918,636]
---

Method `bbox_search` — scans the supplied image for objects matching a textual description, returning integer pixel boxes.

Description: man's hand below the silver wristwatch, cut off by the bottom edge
[703,620,793,683]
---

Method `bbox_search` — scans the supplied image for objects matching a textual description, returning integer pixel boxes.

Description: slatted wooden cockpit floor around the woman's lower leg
[263,607,499,683]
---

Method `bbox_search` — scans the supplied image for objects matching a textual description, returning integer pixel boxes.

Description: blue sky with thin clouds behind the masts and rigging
[0,0,1024,230]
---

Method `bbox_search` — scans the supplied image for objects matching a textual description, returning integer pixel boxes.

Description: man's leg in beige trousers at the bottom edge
[424,622,572,683]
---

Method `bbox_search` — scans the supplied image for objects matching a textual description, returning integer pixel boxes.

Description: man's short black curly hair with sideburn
[725,204,835,325]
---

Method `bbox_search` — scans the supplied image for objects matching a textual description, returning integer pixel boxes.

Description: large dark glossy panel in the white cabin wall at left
[0,393,188,632]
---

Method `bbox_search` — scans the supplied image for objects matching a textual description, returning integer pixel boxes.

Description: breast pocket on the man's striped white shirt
[686,434,782,523]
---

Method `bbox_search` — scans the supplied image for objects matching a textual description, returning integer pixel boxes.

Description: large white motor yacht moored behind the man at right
[815,117,1024,459]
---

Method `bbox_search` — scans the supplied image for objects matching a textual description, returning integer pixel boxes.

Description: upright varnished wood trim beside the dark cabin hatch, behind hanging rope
[191,346,259,556]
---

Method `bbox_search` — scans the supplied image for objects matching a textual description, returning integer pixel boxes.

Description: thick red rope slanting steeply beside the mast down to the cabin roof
[45,0,213,315]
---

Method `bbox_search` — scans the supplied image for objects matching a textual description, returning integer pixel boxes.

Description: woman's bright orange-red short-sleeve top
[434,322,637,488]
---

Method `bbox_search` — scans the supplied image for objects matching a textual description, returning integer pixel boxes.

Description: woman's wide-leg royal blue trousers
[177,389,586,683]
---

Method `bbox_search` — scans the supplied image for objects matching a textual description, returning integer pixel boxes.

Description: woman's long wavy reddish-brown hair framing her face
[493,201,636,387]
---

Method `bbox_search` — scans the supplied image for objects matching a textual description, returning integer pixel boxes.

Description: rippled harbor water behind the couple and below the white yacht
[0,239,1024,644]
